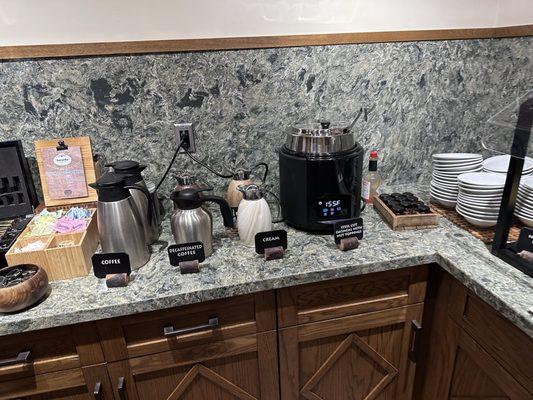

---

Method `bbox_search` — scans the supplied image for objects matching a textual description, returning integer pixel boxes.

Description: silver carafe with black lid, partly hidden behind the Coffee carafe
[106,160,161,244]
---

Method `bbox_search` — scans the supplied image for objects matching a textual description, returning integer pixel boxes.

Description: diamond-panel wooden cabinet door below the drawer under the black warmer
[280,304,422,400]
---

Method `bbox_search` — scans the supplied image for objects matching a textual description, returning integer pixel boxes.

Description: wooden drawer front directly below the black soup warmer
[278,266,427,327]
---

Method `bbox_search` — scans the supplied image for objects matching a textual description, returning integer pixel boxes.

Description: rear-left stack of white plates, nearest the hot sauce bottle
[431,153,483,208]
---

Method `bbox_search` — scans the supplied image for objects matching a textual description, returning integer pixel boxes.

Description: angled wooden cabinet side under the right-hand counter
[416,268,533,400]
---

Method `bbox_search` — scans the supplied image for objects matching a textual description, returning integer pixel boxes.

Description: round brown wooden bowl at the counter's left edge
[0,264,48,313]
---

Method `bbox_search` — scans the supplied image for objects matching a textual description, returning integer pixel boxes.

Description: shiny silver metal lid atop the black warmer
[285,121,357,155]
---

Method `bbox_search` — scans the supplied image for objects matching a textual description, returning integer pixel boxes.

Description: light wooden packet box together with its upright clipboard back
[6,137,98,281]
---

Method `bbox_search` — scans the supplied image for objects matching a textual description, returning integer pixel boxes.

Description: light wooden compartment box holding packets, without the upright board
[6,206,98,281]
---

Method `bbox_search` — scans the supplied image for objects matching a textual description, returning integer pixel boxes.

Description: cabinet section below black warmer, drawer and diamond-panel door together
[278,267,427,400]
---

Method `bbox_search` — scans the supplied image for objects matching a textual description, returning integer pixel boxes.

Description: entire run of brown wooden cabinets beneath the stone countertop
[4,266,533,400]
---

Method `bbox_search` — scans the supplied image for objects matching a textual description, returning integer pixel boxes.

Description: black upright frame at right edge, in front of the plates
[492,97,533,277]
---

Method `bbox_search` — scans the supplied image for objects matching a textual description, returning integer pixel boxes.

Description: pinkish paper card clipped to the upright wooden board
[41,146,88,200]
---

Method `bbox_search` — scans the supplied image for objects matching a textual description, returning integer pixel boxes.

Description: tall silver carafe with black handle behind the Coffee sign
[89,172,152,269]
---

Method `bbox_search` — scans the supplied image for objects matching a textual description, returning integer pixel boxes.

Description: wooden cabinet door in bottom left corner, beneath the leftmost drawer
[0,364,113,400]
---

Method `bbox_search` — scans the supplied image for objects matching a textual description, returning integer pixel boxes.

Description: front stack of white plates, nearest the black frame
[455,172,506,228]
